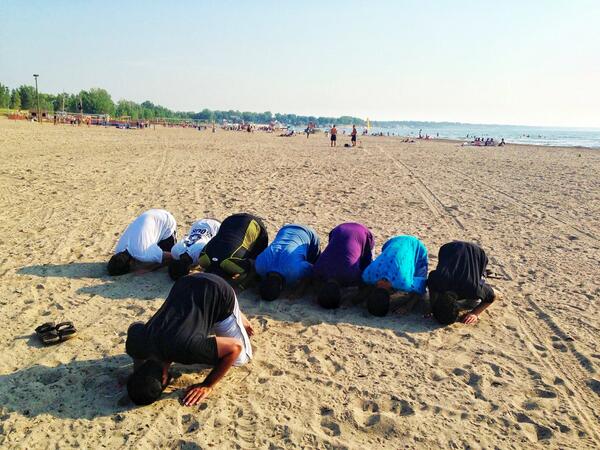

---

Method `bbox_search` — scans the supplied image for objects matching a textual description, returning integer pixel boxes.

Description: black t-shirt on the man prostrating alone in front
[138,274,235,365]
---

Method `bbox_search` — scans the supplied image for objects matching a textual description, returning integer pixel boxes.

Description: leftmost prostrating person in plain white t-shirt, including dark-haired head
[108,209,177,275]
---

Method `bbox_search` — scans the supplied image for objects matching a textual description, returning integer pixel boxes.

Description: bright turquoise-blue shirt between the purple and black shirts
[362,236,428,294]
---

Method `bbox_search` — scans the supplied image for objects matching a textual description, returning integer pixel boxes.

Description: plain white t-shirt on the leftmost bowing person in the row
[115,209,177,264]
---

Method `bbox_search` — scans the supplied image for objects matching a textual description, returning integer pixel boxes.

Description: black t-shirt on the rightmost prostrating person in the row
[427,241,494,302]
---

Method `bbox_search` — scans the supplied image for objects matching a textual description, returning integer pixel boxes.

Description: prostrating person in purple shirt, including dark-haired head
[313,223,375,309]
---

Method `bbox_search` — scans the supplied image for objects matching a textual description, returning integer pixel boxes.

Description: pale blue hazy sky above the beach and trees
[0,0,600,128]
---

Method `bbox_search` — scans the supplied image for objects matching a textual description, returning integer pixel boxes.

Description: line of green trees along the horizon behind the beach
[0,83,365,127]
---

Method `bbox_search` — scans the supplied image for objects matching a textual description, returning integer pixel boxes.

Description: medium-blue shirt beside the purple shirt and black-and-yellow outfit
[255,225,320,287]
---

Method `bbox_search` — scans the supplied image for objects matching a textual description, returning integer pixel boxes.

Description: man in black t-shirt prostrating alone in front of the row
[125,273,254,406]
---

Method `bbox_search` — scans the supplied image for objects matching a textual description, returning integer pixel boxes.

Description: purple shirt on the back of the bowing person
[314,223,374,285]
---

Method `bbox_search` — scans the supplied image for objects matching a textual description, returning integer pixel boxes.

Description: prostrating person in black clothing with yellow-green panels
[198,213,269,282]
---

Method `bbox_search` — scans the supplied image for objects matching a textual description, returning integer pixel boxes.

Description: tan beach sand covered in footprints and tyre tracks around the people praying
[0,119,600,449]
